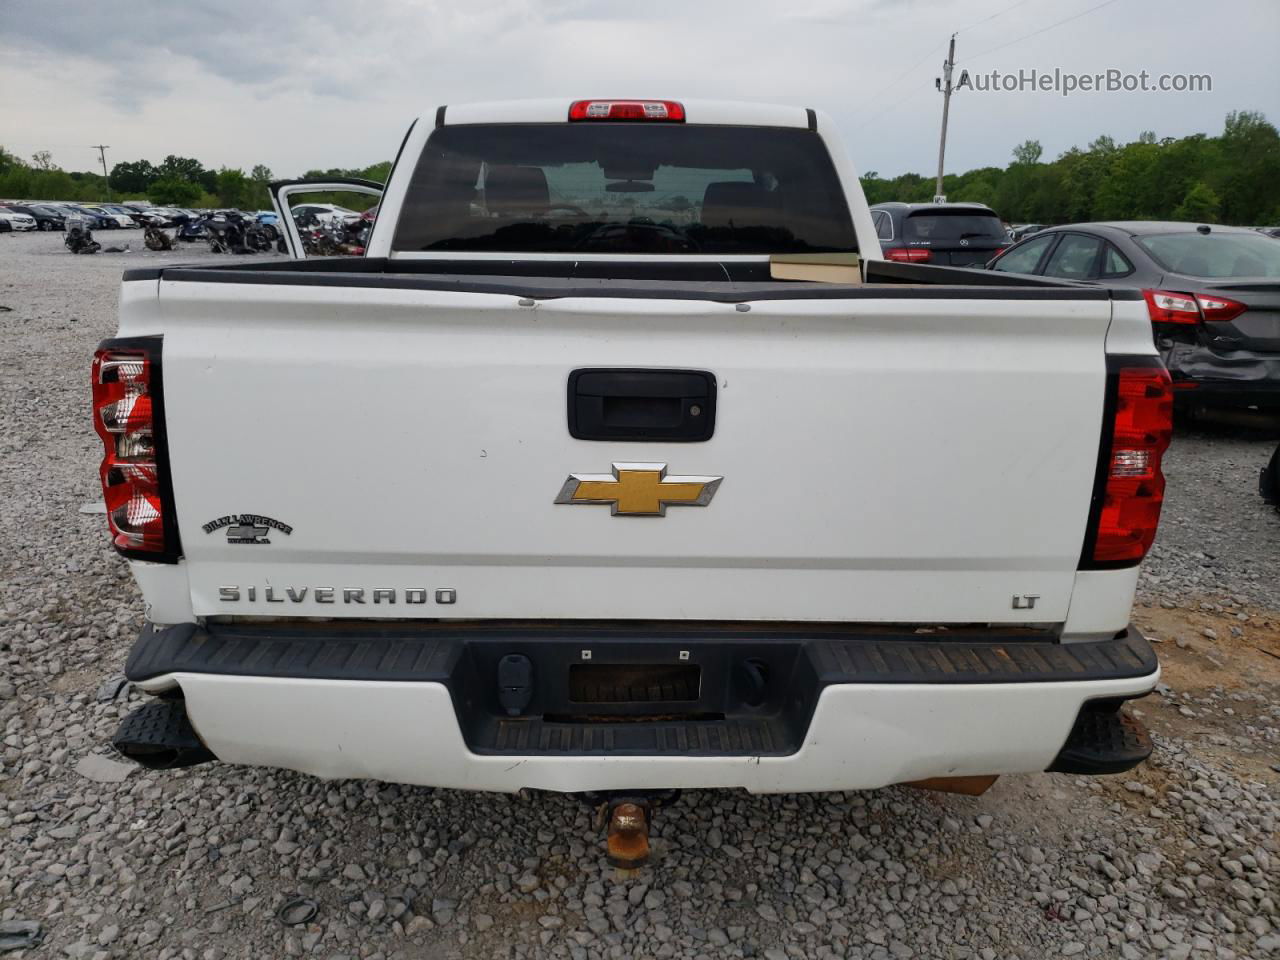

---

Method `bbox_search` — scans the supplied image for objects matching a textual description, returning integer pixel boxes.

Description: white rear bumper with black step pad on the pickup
[127,623,1158,792]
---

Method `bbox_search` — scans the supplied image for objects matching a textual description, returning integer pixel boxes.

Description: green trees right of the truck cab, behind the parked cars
[863,110,1280,227]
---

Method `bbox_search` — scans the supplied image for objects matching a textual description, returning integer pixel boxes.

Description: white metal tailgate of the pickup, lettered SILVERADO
[149,279,1111,623]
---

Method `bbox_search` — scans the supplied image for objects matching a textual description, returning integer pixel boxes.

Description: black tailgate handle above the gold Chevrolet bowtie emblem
[568,367,716,443]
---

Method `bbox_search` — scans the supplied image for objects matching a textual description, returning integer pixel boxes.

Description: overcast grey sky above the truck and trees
[0,0,1280,175]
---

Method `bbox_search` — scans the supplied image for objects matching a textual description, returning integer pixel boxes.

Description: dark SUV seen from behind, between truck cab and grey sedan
[872,202,1009,266]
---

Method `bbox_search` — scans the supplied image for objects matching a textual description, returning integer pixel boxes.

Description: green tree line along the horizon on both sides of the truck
[0,110,1280,225]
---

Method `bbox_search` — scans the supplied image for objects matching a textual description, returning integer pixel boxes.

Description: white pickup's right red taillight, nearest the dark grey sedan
[1080,357,1174,570]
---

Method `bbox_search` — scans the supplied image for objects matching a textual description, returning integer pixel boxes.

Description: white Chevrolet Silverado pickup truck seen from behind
[92,100,1171,819]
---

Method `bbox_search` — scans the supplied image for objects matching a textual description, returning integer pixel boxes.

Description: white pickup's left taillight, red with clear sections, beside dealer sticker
[93,337,178,563]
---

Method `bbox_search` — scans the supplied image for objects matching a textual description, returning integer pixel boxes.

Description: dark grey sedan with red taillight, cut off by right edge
[988,221,1280,408]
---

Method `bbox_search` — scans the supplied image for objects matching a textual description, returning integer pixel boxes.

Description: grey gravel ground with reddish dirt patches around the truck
[0,232,1280,960]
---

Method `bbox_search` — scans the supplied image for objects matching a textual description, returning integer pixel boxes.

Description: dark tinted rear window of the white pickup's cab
[393,123,858,255]
